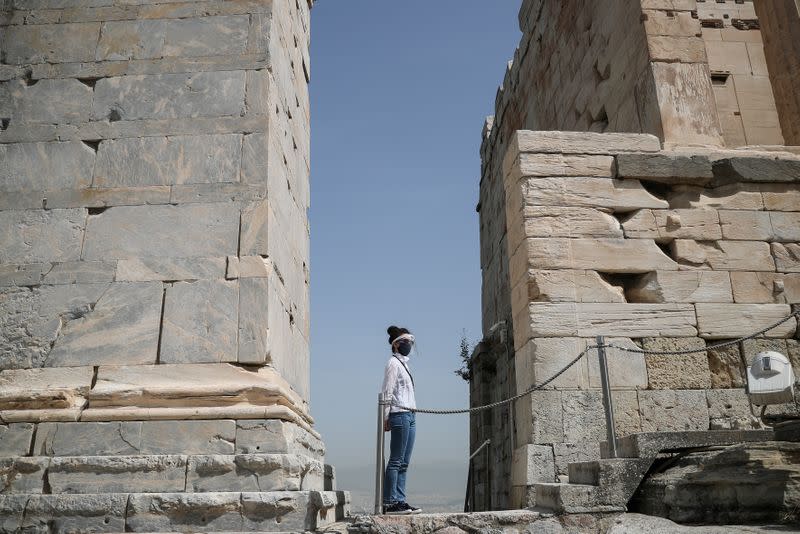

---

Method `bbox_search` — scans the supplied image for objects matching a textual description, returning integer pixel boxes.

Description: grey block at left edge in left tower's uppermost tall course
[0,22,100,65]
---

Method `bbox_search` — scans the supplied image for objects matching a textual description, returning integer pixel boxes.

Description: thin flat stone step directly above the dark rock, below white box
[600,430,775,458]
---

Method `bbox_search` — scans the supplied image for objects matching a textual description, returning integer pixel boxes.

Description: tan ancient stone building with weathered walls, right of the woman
[471,0,800,521]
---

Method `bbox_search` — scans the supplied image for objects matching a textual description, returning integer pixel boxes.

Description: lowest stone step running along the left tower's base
[0,491,350,533]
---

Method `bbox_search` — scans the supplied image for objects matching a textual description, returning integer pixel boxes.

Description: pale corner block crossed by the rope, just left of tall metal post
[514,337,589,391]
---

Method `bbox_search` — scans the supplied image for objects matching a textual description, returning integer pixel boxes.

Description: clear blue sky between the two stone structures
[310,0,520,506]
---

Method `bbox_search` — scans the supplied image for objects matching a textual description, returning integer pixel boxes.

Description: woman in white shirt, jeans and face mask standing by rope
[383,326,422,514]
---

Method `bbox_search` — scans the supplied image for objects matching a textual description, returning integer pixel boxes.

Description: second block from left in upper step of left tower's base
[47,455,187,493]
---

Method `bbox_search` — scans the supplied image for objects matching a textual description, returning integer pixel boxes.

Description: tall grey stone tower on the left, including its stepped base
[0,0,347,532]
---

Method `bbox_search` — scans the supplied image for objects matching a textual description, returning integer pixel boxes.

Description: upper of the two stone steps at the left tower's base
[0,454,325,494]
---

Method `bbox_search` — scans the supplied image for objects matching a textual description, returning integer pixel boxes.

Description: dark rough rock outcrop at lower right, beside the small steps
[632,442,800,528]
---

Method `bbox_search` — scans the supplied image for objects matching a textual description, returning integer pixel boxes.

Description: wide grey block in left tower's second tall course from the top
[92,71,245,121]
